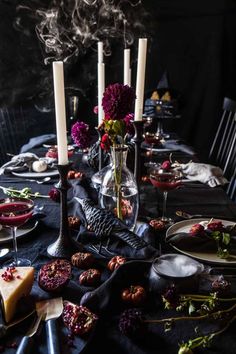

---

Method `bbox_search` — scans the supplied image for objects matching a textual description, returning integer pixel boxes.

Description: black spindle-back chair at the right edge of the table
[209,97,236,178]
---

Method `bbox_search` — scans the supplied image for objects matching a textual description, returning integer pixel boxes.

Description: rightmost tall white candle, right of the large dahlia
[134,38,147,120]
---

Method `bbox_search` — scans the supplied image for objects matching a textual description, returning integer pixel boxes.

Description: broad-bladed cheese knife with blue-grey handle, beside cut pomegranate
[36,297,63,354]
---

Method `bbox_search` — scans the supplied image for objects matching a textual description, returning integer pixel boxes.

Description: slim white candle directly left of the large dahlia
[97,42,105,125]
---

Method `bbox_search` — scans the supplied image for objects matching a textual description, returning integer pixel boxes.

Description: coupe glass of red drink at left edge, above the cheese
[0,197,34,267]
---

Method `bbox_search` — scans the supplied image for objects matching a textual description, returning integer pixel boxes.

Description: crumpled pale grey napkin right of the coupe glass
[177,162,229,187]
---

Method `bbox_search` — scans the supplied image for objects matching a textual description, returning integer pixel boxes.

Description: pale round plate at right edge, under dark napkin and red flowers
[166,218,236,266]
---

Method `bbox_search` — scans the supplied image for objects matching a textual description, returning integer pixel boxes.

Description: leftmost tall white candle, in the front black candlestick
[53,61,68,165]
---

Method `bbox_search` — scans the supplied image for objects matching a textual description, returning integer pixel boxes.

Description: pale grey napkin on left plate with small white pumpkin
[0,152,56,175]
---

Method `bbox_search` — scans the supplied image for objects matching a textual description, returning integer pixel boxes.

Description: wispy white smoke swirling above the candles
[15,0,148,64]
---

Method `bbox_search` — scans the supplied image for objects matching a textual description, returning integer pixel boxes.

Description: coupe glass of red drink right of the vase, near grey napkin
[149,165,182,225]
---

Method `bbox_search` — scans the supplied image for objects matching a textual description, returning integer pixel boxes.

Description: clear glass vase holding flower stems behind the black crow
[99,146,139,230]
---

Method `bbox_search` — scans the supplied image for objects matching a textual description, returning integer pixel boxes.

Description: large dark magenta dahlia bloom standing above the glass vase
[102,83,135,120]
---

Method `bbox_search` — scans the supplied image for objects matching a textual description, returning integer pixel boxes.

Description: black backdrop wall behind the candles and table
[0,0,236,160]
